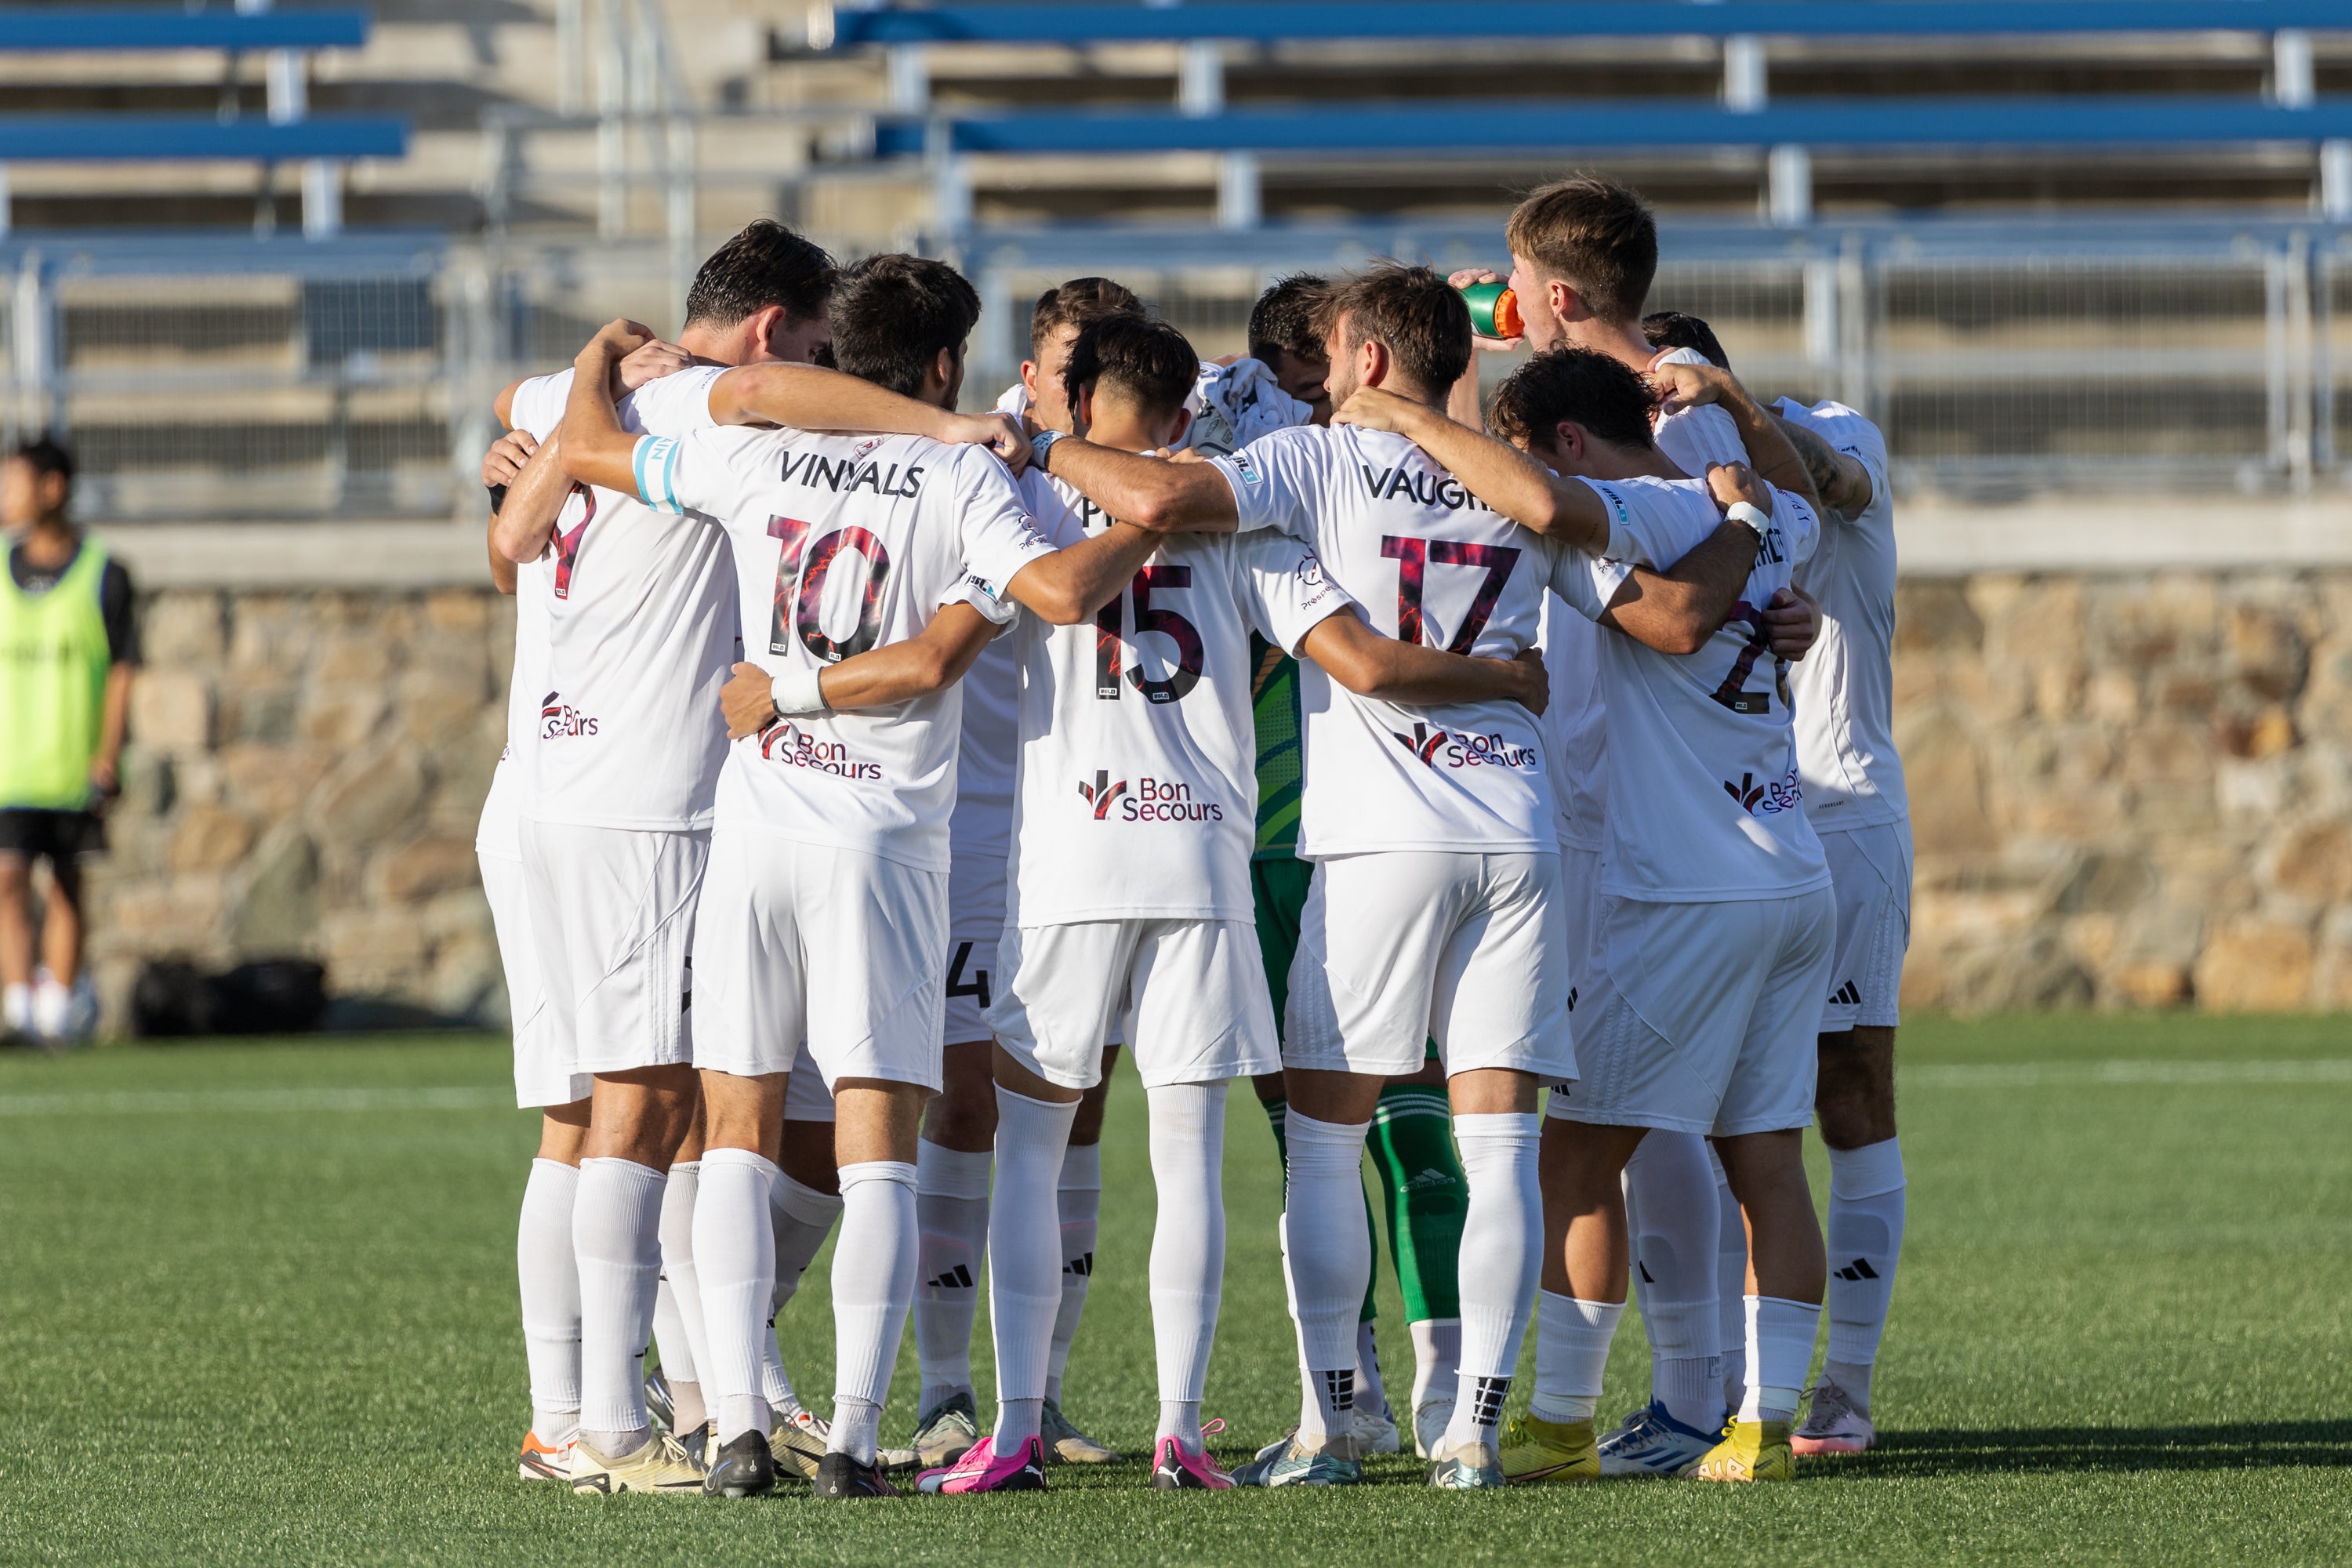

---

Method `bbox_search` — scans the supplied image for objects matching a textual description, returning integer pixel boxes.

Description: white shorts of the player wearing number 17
[1282,851,1576,1081]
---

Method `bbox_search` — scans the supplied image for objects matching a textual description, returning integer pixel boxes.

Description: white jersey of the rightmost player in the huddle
[1778,397,1910,832]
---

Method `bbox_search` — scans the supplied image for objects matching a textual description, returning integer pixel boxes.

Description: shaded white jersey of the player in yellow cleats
[1559,479,1830,902]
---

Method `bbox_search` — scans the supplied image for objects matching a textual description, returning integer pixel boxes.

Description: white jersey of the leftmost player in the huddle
[513,367,736,832]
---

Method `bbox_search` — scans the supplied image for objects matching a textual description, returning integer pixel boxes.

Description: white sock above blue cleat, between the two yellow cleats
[1625,1131,1724,1432]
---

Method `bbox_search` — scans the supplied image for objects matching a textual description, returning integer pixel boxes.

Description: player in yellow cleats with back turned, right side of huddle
[1341,350,1835,1481]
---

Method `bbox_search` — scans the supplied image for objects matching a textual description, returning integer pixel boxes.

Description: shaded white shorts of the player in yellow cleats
[1548,888,1837,1138]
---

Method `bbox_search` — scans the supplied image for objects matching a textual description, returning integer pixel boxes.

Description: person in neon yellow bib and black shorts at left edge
[0,437,139,1046]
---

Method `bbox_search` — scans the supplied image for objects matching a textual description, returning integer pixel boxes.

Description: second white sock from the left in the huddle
[572,1159,668,1460]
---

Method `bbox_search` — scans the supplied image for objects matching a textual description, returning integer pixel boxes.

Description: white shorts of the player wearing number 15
[988,919,1282,1088]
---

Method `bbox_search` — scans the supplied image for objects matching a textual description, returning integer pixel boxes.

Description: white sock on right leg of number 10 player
[828,1159,915,1465]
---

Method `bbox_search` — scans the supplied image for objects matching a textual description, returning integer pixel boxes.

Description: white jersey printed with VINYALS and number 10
[637,428,1051,872]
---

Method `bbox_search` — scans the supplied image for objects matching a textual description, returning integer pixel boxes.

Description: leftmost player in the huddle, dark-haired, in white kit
[492,221,833,1493]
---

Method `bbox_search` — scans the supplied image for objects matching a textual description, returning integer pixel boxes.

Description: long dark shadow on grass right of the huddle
[1835,1420,2352,1481]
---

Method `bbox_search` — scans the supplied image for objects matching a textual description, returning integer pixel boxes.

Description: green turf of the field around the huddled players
[0,1018,2352,1568]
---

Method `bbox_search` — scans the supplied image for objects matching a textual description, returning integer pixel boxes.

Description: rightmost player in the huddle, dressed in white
[1668,343,1912,1455]
